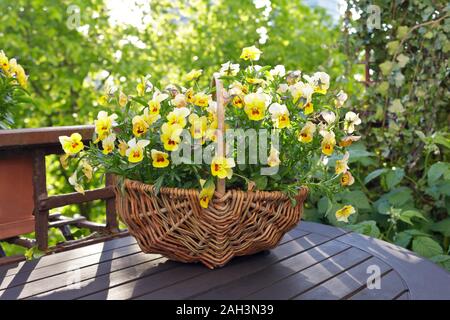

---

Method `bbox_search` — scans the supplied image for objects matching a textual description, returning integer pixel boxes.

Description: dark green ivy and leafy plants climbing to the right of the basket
[306,0,450,270]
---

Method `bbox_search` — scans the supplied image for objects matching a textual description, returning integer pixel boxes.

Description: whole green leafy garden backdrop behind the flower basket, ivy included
[0,0,450,269]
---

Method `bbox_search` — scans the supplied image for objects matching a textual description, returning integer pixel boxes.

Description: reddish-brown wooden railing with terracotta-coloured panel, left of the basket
[0,126,122,257]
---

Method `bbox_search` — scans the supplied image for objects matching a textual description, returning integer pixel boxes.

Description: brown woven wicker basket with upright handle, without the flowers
[116,74,307,269]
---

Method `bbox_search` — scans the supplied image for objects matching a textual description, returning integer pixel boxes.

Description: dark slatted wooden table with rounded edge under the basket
[0,222,450,300]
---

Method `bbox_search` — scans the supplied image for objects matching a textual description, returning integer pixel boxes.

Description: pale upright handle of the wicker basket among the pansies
[211,73,225,195]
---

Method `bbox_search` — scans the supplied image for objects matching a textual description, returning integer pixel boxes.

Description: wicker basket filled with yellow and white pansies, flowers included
[60,46,361,268]
